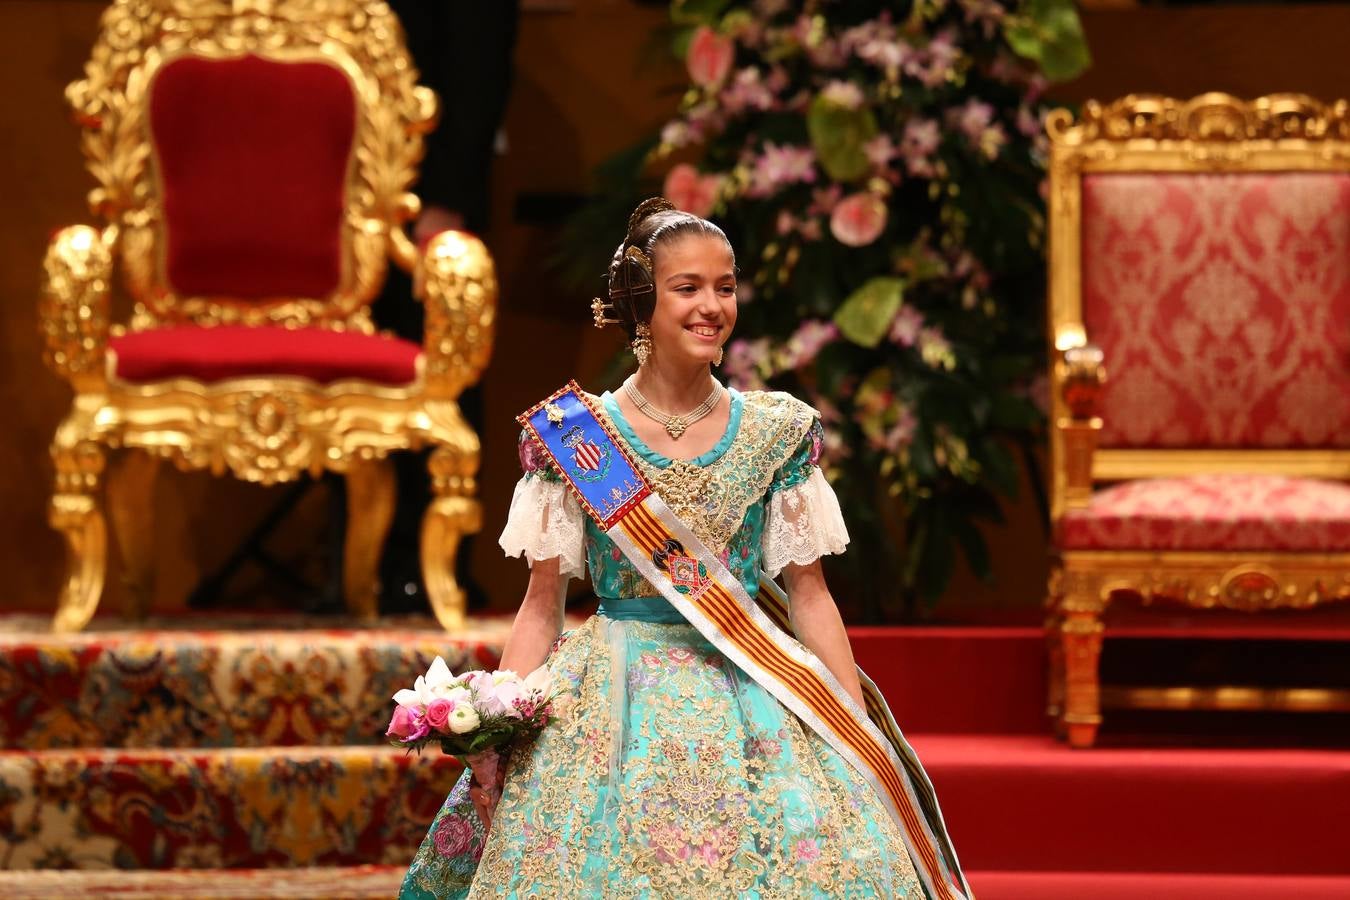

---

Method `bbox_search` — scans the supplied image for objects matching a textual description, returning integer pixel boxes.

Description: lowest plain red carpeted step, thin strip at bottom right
[968,872,1350,900]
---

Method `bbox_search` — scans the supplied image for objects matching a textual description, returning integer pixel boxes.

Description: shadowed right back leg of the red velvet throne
[343,459,394,621]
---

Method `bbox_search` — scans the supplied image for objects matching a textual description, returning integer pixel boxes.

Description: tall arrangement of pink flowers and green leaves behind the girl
[572,0,1088,619]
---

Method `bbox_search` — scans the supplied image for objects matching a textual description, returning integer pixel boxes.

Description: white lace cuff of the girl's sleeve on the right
[763,466,848,578]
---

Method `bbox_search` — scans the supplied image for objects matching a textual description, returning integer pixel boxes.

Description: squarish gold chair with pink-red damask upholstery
[1048,94,1350,746]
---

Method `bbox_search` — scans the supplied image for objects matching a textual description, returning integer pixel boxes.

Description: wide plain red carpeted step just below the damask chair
[914,734,1350,874]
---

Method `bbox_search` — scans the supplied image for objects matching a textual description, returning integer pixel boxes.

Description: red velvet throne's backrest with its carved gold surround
[66,0,436,332]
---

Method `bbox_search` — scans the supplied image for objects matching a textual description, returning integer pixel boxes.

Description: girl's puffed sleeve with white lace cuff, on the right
[763,420,849,578]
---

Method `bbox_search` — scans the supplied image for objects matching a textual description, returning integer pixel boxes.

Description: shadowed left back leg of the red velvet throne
[108,449,161,619]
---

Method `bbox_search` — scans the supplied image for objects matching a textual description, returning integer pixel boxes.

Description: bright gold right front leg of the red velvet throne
[421,447,483,631]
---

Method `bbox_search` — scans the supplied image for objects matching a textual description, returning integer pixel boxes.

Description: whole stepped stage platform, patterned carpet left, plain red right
[0,615,1350,900]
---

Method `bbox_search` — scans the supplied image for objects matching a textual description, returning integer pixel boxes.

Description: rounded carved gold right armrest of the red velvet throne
[414,231,497,399]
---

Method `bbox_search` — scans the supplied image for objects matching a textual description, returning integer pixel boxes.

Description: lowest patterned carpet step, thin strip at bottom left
[0,866,406,900]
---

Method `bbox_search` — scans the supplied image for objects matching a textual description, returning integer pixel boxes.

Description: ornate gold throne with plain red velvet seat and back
[42,0,497,630]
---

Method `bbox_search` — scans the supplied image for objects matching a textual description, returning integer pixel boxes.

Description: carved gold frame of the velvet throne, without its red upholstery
[41,0,497,630]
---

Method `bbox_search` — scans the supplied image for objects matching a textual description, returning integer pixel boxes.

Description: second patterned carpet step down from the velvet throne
[0,746,460,869]
